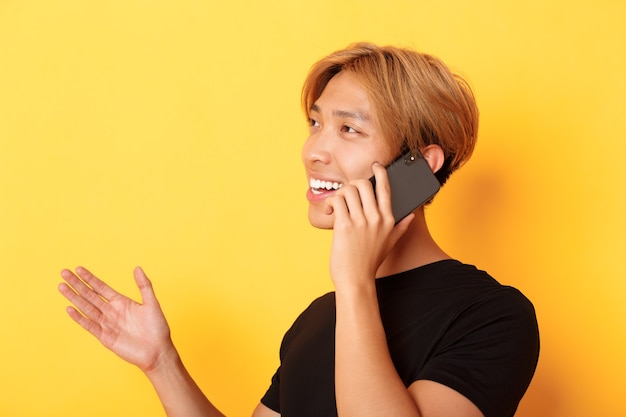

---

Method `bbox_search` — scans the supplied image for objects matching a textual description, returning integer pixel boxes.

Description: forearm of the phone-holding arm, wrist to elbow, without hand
[335,283,420,417]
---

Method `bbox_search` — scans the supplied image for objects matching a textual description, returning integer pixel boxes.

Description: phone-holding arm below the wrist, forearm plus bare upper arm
[335,287,483,417]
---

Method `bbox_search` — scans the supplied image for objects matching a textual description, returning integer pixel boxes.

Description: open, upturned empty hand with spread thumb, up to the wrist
[59,268,173,370]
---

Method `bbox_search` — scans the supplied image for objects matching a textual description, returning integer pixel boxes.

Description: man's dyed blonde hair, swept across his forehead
[302,43,478,184]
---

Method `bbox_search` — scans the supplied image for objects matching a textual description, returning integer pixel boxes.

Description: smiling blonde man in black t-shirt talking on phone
[60,44,539,417]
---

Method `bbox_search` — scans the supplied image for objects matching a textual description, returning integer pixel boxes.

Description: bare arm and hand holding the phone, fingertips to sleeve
[326,164,483,417]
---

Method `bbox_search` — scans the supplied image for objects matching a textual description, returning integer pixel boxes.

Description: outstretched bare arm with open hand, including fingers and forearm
[59,268,223,417]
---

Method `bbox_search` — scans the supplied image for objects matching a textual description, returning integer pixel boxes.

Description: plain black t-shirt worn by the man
[261,260,539,417]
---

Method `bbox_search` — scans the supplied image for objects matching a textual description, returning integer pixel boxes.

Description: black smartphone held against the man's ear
[370,151,440,223]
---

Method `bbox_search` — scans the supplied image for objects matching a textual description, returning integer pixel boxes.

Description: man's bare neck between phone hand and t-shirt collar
[376,207,450,278]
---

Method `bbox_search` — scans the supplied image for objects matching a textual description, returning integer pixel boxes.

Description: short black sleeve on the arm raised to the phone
[416,287,539,417]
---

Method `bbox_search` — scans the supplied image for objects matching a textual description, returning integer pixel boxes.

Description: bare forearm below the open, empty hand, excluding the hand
[145,350,224,417]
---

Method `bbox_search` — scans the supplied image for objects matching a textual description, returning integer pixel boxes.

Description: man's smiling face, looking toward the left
[302,72,392,229]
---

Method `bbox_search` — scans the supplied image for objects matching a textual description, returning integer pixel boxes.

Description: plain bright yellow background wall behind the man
[0,0,626,417]
